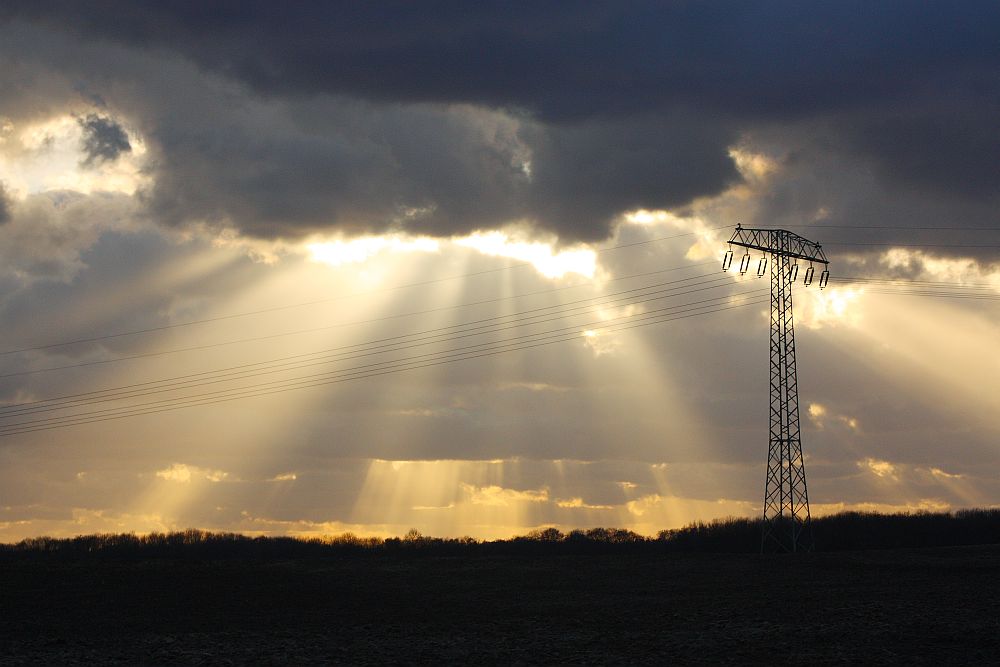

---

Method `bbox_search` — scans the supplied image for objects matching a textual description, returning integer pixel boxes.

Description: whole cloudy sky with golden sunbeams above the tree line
[0,0,1000,541]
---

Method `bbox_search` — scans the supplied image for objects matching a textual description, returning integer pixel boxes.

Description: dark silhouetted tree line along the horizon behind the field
[0,508,1000,559]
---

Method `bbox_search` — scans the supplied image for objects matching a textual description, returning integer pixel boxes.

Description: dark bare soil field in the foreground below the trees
[0,546,1000,665]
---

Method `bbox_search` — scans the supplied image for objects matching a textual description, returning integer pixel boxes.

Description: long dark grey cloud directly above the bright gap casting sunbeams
[143,102,739,240]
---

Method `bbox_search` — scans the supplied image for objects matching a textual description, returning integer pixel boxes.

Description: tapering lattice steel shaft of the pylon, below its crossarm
[761,253,813,552]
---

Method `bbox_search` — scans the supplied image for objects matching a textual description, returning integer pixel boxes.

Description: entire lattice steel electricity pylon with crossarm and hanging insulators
[722,225,830,552]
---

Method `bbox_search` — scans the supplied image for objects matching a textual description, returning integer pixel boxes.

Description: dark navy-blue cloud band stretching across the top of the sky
[8,0,1000,118]
